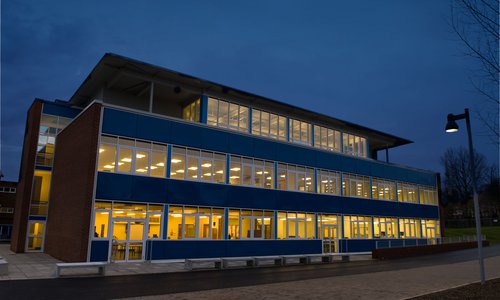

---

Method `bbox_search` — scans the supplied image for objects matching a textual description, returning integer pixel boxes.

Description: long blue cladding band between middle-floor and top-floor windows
[102,108,436,186]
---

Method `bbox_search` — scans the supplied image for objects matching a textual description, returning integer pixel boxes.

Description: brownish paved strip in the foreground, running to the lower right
[123,256,500,300]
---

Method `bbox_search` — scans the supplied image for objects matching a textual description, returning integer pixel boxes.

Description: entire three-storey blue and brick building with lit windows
[11,54,441,262]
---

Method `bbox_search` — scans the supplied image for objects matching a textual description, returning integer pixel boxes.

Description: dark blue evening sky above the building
[0,0,498,180]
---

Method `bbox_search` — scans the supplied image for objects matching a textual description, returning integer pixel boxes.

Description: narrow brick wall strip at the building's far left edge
[10,100,42,253]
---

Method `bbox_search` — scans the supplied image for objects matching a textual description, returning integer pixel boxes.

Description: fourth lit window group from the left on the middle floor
[278,164,315,193]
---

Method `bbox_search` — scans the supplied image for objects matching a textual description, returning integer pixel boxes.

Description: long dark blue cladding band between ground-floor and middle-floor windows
[96,172,439,219]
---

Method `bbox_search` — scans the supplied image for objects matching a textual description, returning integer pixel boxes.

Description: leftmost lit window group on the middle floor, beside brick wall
[97,136,167,177]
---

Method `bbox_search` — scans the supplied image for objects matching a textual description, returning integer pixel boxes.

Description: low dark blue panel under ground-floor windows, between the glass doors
[146,240,322,259]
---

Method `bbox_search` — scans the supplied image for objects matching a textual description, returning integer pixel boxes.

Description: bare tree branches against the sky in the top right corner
[450,0,500,144]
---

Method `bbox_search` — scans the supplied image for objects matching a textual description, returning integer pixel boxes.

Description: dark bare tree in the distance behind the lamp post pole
[441,147,492,203]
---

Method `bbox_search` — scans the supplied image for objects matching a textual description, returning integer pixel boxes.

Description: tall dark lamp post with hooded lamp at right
[445,108,484,284]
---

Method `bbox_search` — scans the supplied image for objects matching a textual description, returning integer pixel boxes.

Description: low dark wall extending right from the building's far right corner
[372,241,490,259]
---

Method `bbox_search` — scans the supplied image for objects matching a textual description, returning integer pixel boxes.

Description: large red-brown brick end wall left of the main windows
[45,103,102,262]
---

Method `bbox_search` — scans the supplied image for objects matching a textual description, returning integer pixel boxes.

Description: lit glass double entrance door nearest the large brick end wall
[111,219,145,261]
